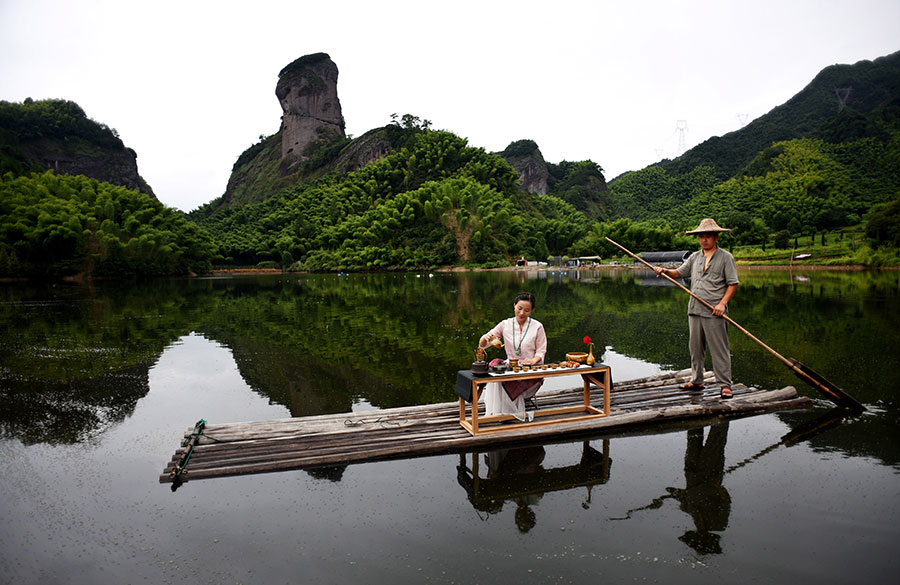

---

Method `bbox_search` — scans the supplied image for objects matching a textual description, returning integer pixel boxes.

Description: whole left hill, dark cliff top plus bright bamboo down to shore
[0,99,216,279]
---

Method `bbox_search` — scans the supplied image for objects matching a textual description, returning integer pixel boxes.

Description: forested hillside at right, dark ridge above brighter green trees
[610,52,900,235]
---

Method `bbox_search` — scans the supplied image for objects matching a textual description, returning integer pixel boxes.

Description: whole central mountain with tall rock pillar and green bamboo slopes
[189,53,608,271]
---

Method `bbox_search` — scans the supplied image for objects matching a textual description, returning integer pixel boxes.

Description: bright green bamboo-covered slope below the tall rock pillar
[191,128,599,270]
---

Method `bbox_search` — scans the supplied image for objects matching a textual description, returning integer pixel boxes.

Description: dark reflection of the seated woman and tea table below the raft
[456,439,612,532]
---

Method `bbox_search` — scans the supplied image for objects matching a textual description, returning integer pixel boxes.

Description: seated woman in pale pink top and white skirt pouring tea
[478,292,547,420]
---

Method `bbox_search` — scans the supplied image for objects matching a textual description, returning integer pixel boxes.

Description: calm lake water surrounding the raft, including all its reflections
[0,270,900,584]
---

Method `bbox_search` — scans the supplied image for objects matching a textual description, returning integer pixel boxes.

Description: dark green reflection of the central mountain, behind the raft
[202,274,600,414]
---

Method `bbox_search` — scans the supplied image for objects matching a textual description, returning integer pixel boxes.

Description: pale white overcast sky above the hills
[0,0,900,211]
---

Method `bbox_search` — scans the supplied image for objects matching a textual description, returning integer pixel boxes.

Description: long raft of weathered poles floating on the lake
[159,370,812,485]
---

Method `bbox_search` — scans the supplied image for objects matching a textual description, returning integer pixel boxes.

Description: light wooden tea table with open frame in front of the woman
[457,364,612,435]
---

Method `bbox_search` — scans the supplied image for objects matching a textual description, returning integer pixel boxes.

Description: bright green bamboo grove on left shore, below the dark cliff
[0,171,215,277]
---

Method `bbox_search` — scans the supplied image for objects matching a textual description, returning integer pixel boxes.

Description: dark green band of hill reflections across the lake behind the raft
[0,269,900,454]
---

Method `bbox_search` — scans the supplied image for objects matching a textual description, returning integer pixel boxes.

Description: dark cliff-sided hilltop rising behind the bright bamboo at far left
[0,98,153,196]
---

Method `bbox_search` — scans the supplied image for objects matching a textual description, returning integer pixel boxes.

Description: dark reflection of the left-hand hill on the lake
[0,280,207,444]
